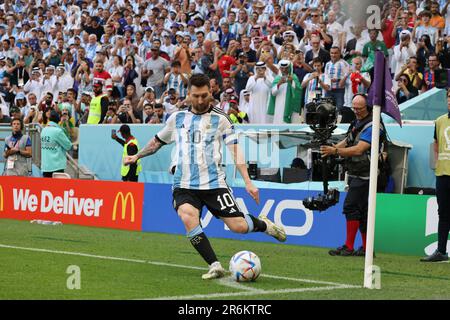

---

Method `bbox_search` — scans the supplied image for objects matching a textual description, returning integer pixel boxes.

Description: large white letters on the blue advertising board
[201,198,314,236]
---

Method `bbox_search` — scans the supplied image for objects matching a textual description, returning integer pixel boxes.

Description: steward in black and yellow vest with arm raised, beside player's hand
[111,124,142,182]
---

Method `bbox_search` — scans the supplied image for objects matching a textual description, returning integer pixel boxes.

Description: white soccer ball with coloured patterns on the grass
[230,250,261,282]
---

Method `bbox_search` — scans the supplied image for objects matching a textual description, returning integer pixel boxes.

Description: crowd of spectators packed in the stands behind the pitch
[0,0,450,135]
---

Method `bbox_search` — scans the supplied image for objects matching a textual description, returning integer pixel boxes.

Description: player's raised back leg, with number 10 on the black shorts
[204,188,286,242]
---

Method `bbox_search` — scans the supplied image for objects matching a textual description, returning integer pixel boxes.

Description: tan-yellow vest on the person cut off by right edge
[435,114,450,176]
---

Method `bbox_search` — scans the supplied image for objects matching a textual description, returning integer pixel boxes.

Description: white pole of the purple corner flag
[364,105,381,289]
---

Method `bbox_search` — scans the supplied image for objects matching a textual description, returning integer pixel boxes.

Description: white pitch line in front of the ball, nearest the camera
[149,285,362,300]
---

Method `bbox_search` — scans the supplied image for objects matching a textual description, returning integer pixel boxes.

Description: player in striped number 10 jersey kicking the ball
[124,74,286,279]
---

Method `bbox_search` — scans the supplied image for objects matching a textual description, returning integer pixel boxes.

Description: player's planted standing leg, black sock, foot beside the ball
[173,189,225,279]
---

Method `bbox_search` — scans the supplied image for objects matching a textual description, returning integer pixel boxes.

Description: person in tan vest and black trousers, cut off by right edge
[420,90,450,262]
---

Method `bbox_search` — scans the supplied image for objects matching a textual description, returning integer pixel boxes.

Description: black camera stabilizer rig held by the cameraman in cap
[303,97,339,211]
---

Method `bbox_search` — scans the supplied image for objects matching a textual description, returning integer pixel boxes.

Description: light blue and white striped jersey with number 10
[156,107,237,190]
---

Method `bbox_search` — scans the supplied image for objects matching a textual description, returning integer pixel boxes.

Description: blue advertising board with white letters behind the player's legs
[142,184,346,248]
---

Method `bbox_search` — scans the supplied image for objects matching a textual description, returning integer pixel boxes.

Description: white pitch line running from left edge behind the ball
[0,244,354,287]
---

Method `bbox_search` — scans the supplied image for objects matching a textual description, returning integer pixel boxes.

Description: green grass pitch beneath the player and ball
[0,220,450,300]
